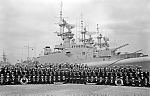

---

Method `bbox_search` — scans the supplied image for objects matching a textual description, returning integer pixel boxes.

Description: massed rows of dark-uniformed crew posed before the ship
[0,63,150,87]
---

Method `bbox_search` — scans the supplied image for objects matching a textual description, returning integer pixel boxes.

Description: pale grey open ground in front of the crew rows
[0,84,150,96]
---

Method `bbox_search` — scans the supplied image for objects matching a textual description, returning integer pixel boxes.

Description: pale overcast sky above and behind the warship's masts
[0,0,150,63]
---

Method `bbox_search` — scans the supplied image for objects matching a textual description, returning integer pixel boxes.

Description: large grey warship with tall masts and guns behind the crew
[37,4,150,70]
